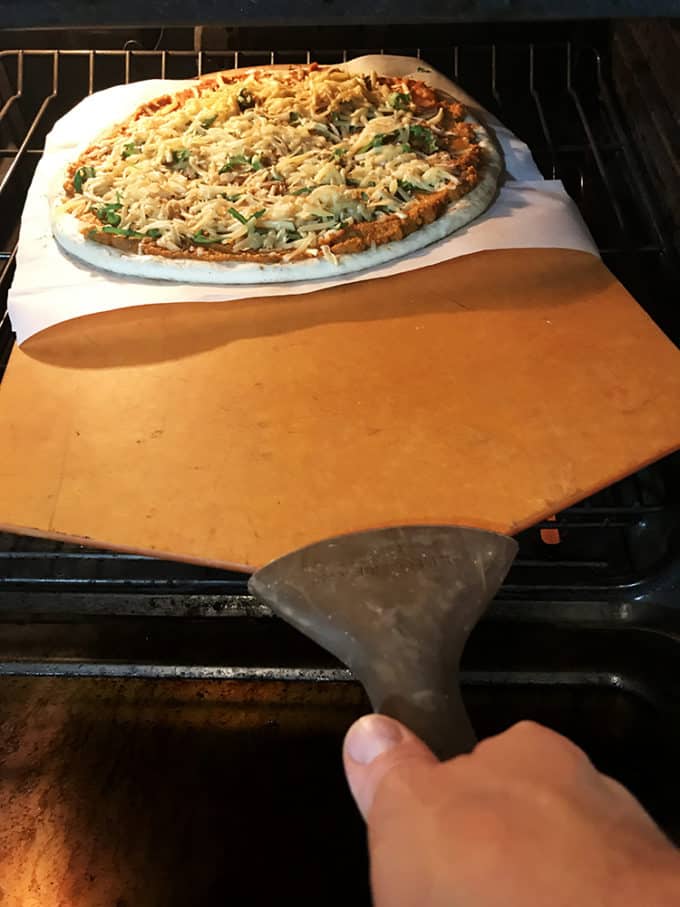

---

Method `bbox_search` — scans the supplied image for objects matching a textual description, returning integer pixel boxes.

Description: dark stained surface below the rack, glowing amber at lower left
[0,677,678,907]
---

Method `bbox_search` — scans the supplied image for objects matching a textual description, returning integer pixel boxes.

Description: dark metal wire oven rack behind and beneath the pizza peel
[0,40,680,640]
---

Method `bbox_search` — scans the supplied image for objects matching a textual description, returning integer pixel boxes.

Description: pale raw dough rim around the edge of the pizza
[49,67,504,285]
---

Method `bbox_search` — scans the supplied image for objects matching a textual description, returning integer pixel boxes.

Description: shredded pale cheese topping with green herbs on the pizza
[63,68,478,260]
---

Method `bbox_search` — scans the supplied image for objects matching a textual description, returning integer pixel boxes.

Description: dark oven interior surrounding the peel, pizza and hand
[0,8,680,907]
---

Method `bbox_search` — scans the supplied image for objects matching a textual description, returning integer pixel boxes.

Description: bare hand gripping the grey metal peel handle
[344,715,680,907]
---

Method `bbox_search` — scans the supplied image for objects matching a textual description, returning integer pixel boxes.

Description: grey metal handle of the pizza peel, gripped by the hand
[248,526,517,759]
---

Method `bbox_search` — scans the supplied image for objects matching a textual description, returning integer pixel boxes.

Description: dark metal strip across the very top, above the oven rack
[0,0,680,28]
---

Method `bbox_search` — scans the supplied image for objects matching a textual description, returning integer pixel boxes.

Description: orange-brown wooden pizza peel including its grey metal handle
[0,249,680,755]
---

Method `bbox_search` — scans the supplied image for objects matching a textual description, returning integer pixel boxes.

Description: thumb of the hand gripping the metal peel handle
[342,715,437,819]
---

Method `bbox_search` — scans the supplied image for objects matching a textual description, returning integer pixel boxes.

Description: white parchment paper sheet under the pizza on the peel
[8,56,598,343]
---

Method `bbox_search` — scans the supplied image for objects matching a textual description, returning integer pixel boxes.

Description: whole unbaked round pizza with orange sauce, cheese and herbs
[50,64,502,283]
